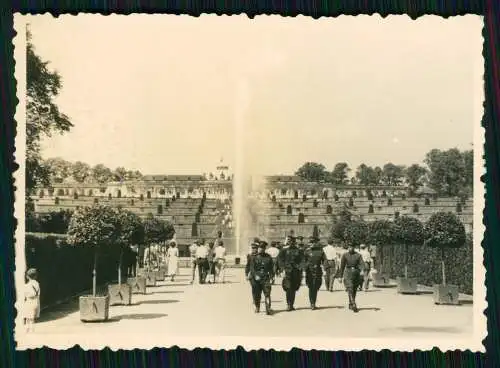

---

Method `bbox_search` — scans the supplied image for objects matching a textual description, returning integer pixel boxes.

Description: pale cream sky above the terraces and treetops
[28,14,483,174]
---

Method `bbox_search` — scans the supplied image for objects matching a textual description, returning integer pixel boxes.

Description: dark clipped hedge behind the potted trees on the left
[25,233,119,308]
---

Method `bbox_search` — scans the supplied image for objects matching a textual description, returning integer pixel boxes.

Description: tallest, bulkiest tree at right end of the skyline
[425,148,472,196]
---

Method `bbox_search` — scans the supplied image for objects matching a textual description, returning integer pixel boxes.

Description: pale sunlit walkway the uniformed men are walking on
[17,269,473,343]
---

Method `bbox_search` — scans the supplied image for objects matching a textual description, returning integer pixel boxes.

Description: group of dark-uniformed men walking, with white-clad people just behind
[245,231,373,315]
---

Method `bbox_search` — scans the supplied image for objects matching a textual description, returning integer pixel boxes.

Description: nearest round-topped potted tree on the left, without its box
[68,205,119,296]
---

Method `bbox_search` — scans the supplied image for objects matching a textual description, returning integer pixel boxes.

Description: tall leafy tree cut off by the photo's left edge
[26,28,73,195]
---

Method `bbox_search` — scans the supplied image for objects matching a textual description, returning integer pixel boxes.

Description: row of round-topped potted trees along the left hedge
[68,205,175,296]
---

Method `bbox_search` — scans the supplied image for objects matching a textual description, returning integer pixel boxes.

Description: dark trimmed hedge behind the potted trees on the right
[377,234,473,295]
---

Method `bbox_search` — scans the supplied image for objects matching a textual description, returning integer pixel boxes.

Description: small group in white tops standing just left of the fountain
[189,232,226,284]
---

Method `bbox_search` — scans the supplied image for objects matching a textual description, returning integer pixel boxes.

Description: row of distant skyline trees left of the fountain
[42,157,142,184]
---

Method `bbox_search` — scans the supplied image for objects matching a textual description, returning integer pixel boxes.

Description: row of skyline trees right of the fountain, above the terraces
[295,148,474,196]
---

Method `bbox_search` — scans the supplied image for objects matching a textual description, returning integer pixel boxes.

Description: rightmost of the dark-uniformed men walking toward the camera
[340,245,363,312]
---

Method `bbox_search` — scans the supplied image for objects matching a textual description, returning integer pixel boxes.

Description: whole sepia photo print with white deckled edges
[14,14,486,351]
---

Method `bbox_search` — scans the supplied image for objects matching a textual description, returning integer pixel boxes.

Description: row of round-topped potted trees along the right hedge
[332,209,466,284]
